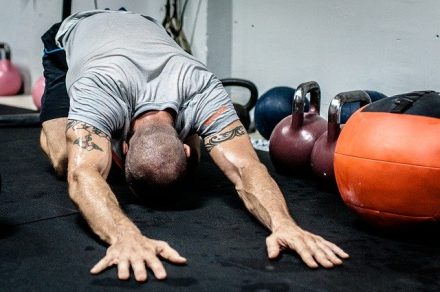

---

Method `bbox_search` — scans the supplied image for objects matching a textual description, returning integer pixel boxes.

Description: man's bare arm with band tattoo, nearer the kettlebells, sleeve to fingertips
[204,121,348,268]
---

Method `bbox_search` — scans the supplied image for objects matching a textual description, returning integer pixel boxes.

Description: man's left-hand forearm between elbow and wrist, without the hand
[69,171,139,244]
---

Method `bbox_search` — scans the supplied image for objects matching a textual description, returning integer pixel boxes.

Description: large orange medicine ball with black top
[334,91,440,226]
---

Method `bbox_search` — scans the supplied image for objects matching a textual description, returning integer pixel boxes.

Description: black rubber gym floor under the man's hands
[0,106,440,291]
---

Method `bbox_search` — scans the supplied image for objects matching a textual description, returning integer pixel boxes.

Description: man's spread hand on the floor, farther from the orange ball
[90,234,186,282]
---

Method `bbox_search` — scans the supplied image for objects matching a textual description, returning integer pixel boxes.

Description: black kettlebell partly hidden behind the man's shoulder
[220,78,258,130]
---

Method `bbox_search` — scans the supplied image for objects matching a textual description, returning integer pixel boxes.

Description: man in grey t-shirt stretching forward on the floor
[40,11,348,281]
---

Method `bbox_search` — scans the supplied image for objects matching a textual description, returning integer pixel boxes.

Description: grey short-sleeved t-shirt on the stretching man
[56,10,238,144]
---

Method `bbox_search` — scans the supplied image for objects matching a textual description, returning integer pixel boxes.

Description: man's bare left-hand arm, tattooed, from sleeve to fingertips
[66,120,186,281]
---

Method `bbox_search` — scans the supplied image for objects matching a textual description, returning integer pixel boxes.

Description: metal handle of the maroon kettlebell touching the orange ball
[327,90,371,142]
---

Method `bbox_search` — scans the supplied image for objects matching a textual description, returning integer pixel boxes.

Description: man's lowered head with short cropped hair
[125,124,187,196]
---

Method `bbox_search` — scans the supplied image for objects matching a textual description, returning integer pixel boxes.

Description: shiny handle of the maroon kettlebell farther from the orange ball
[292,81,321,129]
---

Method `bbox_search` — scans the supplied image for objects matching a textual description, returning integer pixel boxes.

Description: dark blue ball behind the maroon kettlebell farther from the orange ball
[254,86,309,140]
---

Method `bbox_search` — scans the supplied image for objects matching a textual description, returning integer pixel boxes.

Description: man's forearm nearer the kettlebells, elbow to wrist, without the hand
[236,163,293,231]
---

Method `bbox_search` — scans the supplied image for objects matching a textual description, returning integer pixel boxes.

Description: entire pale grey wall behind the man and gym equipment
[0,0,440,115]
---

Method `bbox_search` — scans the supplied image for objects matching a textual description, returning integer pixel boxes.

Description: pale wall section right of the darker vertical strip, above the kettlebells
[232,0,440,115]
